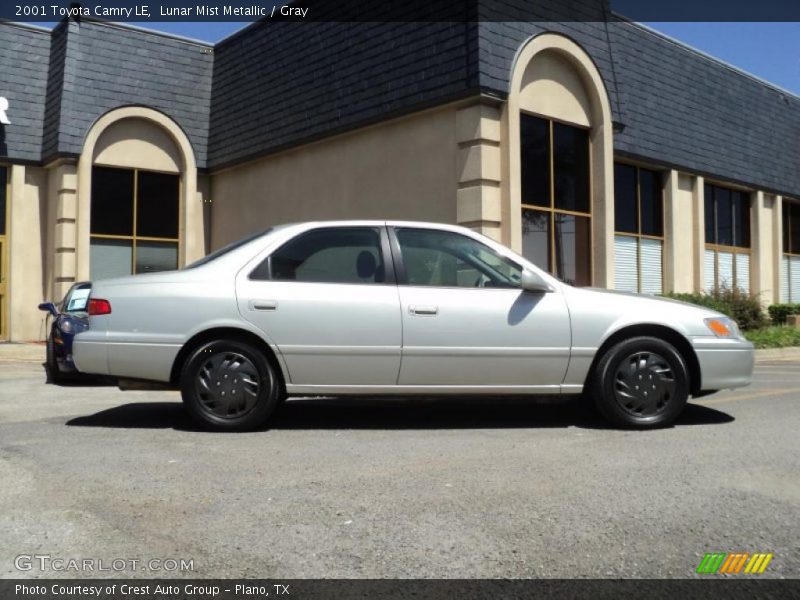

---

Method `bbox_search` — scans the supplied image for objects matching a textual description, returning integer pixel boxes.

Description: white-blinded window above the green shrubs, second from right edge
[704,184,750,293]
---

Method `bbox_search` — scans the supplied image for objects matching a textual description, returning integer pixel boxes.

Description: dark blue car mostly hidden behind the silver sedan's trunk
[39,281,92,383]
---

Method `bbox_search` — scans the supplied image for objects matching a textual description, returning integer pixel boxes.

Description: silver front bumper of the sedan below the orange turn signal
[692,337,755,391]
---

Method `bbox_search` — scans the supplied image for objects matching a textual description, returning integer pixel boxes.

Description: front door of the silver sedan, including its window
[392,227,571,392]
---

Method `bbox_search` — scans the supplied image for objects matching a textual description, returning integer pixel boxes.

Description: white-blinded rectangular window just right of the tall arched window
[614,163,664,294]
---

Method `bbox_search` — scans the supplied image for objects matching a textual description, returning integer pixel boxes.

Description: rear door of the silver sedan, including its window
[237,226,401,391]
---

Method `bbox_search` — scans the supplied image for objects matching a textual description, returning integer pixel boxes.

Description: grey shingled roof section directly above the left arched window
[44,21,213,167]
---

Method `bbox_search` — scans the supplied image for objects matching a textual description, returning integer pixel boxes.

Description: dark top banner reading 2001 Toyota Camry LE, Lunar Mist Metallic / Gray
[0,0,800,23]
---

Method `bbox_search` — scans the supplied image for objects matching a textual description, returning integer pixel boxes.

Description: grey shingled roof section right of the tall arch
[609,23,800,195]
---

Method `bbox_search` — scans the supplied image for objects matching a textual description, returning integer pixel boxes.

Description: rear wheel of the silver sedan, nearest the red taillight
[180,340,282,431]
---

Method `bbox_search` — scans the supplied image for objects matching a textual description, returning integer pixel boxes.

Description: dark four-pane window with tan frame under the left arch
[90,167,180,279]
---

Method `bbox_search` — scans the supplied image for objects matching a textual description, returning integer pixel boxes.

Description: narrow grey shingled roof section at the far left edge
[0,24,50,161]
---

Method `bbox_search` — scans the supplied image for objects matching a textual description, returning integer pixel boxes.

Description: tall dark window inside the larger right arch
[520,113,592,286]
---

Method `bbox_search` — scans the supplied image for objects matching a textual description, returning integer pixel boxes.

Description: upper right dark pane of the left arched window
[136,171,180,239]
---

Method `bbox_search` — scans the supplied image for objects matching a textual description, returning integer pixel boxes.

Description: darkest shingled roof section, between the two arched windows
[209,18,477,167]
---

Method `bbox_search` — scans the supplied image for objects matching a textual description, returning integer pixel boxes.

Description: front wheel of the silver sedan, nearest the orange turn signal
[590,337,689,429]
